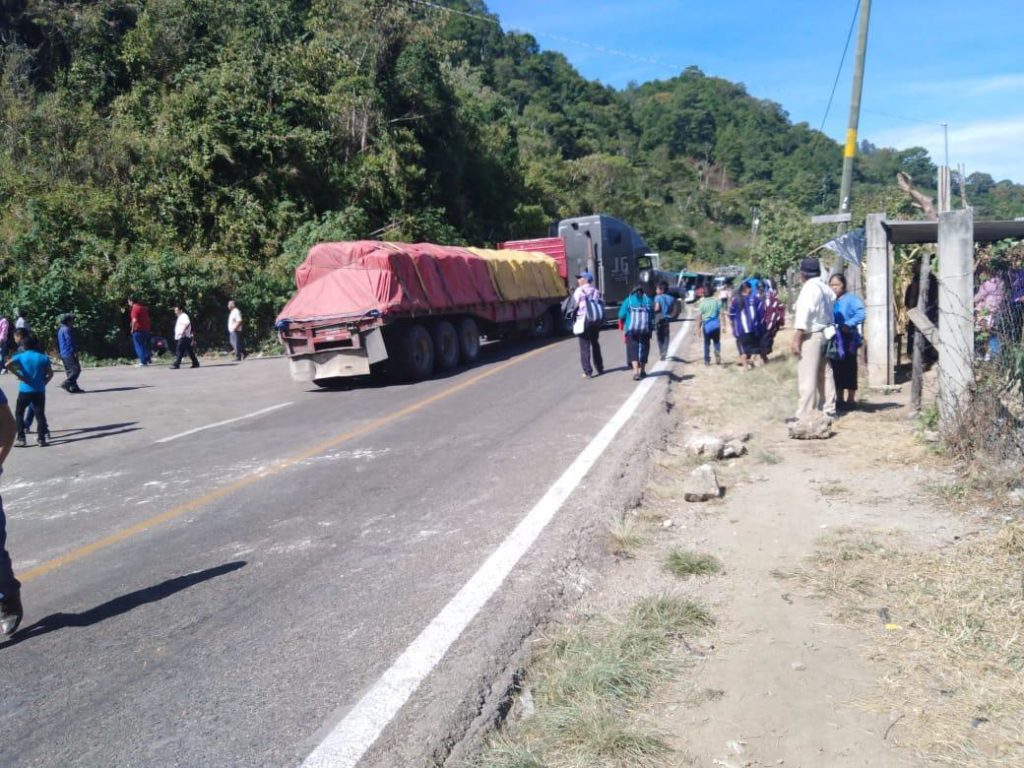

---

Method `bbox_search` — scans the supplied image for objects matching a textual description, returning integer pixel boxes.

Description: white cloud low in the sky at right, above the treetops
[864,115,1024,183]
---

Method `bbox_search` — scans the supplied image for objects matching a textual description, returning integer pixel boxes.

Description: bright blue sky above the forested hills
[479,0,1024,183]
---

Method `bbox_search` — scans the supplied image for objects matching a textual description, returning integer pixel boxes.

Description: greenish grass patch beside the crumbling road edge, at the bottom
[476,595,714,768]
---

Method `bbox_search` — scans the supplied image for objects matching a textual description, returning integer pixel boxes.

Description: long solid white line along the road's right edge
[301,324,690,768]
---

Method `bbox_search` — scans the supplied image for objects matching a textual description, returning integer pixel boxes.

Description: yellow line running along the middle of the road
[17,344,552,584]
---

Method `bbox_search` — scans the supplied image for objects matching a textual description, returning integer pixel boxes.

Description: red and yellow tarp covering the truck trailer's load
[278,241,566,322]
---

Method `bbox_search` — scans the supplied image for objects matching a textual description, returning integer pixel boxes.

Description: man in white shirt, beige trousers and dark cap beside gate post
[791,258,836,420]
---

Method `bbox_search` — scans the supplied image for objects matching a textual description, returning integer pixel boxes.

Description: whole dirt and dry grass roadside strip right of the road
[480,323,1024,768]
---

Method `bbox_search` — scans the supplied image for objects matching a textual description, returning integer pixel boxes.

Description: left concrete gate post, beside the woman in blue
[864,213,896,387]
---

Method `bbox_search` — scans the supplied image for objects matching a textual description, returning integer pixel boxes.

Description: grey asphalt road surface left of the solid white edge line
[0,326,681,767]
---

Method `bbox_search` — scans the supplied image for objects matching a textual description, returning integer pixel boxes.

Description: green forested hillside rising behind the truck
[0,0,1024,353]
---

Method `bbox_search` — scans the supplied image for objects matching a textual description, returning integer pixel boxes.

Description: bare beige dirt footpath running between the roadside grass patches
[651,327,959,768]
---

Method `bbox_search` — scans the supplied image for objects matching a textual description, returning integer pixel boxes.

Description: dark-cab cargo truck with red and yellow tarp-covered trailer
[276,216,667,386]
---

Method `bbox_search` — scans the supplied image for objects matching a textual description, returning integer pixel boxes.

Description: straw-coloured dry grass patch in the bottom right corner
[799,522,1024,768]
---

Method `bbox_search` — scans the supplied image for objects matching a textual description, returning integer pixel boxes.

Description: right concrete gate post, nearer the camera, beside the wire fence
[939,208,974,428]
